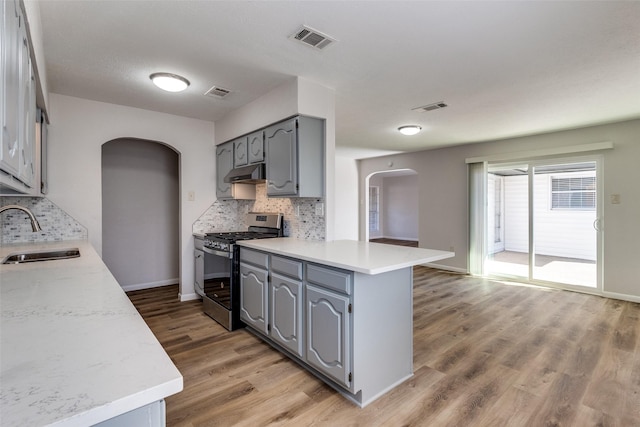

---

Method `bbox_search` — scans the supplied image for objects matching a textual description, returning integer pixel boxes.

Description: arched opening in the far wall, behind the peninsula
[364,169,420,247]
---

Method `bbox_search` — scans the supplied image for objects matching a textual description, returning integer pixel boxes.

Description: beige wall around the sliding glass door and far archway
[359,120,640,301]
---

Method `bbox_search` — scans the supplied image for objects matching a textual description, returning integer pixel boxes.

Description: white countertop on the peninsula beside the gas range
[237,237,455,274]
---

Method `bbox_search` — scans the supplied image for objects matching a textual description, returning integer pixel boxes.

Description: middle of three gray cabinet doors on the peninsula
[269,273,303,357]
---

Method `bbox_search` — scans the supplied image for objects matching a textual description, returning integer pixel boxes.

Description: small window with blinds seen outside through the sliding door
[551,176,596,211]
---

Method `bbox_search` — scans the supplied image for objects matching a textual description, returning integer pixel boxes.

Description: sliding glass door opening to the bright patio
[480,157,602,289]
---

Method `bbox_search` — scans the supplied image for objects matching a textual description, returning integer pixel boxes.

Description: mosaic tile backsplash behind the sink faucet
[0,196,88,245]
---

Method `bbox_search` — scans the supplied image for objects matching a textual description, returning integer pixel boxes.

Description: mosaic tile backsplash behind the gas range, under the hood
[193,184,325,240]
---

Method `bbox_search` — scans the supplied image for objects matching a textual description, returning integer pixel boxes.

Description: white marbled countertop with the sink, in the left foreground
[0,241,183,427]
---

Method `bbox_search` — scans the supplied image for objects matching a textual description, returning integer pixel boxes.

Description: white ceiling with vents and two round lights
[36,0,640,157]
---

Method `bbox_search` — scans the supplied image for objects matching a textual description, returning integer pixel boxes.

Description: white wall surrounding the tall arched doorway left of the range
[48,93,215,300]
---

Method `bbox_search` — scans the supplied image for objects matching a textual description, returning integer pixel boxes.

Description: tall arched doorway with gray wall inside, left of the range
[101,138,180,291]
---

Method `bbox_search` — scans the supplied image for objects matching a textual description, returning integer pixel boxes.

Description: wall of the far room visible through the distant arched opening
[382,175,420,241]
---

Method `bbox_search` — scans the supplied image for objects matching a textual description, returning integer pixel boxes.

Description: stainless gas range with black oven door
[196,212,283,331]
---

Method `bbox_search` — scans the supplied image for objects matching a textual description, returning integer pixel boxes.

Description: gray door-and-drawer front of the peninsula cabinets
[240,248,352,389]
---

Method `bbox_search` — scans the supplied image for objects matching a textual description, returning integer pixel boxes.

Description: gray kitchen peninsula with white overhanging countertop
[238,238,455,407]
